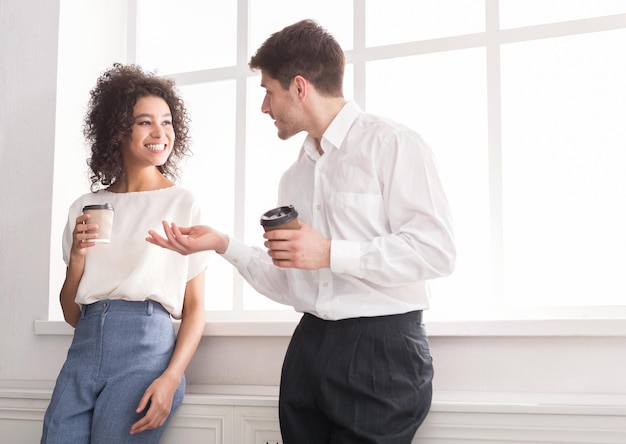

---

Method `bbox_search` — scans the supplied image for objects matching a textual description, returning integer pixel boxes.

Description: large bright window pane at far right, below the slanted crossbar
[502,30,626,306]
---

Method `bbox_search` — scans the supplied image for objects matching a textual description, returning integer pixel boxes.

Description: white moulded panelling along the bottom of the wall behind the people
[0,381,626,444]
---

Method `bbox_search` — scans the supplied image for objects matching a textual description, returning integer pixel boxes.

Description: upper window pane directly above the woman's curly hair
[137,0,237,74]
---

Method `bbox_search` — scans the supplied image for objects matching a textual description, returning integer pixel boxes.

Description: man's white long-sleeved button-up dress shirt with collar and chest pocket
[224,102,456,320]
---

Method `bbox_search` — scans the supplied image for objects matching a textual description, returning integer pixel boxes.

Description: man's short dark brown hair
[248,20,345,97]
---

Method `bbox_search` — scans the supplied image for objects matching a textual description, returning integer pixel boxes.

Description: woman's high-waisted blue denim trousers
[41,300,185,444]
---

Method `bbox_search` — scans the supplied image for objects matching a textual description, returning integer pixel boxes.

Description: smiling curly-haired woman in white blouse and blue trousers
[41,64,206,444]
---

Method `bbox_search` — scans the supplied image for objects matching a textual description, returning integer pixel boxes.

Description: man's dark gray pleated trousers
[279,311,433,444]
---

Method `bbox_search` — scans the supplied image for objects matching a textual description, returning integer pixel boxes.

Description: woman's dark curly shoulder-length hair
[83,63,190,191]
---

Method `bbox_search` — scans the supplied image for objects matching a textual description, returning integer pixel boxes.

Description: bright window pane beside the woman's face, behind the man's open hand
[180,80,235,310]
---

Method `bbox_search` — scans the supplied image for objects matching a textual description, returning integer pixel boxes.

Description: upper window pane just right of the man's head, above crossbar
[365,0,485,46]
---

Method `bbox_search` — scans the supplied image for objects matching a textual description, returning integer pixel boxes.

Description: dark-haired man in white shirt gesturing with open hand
[148,20,455,444]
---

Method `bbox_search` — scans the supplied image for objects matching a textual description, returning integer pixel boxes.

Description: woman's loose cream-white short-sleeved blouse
[63,186,208,319]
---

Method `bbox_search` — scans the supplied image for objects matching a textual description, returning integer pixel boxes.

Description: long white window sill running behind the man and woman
[33,319,626,337]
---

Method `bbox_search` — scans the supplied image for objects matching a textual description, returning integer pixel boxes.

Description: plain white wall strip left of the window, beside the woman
[0,0,62,379]
